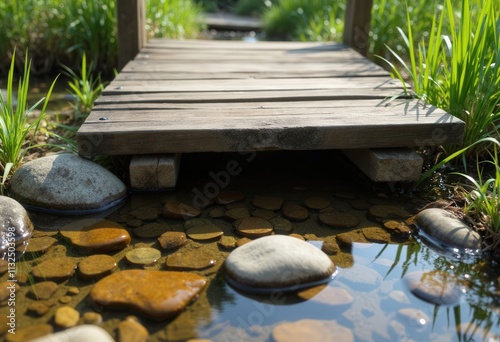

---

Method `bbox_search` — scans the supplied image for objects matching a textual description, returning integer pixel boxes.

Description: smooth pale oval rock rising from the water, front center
[224,235,336,292]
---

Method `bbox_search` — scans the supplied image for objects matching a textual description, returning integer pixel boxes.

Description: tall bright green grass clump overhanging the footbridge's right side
[382,0,500,156]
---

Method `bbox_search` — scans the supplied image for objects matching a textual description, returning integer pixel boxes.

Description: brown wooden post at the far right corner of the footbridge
[344,0,373,56]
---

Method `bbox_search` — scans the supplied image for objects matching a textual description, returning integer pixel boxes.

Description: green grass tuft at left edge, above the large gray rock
[0,51,57,184]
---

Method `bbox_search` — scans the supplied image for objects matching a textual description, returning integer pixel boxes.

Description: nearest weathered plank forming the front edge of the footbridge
[77,100,464,155]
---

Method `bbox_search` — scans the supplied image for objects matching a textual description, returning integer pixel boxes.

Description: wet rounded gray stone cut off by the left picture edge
[0,196,33,259]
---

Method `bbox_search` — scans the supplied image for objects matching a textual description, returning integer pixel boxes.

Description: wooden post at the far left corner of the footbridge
[116,0,146,71]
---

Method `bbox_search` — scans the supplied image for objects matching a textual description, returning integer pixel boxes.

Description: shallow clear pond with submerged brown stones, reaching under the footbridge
[0,151,500,341]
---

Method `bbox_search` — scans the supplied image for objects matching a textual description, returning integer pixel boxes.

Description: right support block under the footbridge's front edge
[342,148,423,182]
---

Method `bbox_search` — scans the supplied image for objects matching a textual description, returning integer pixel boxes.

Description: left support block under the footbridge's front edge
[129,154,181,190]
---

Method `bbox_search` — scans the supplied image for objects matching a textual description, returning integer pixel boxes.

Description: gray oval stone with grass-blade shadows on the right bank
[414,208,481,250]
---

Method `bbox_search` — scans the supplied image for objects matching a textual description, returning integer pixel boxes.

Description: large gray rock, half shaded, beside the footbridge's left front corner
[10,153,127,211]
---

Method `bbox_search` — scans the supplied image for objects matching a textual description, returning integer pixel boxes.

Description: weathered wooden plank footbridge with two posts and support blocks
[77,0,464,188]
